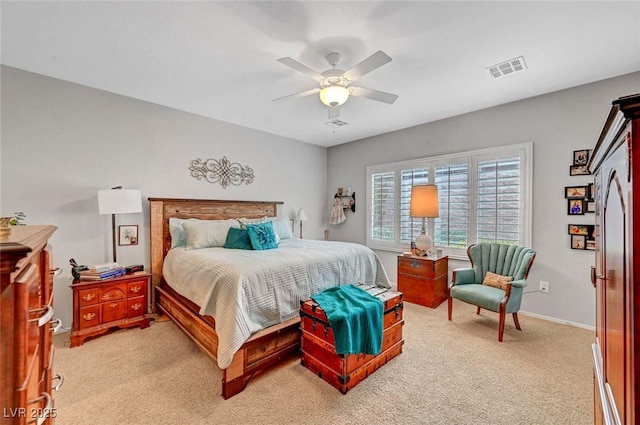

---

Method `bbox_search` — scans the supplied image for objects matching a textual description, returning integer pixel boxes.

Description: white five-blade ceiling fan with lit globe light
[273,50,398,119]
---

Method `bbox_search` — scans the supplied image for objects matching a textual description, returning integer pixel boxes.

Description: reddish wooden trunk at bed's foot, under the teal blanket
[300,287,404,394]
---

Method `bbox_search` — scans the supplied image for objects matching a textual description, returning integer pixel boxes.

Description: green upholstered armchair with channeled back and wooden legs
[447,243,536,342]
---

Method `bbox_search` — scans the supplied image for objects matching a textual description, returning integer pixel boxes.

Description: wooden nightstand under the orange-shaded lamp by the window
[398,255,449,308]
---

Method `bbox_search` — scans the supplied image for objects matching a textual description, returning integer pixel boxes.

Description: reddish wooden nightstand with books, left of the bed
[71,272,151,347]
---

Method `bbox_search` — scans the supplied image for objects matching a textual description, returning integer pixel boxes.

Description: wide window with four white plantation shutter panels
[367,143,532,259]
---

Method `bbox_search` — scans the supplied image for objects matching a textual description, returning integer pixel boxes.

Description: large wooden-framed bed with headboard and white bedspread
[149,198,389,399]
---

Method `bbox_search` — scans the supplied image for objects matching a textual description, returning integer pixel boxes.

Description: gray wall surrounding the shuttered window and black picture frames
[327,73,640,327]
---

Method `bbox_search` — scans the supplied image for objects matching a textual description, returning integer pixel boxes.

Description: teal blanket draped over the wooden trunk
[311,285,384,354]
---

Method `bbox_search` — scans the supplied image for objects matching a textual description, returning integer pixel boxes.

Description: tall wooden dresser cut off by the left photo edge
[0,226,62,425]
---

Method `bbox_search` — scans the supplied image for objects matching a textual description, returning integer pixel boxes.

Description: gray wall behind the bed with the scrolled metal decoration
[0,66,327,327]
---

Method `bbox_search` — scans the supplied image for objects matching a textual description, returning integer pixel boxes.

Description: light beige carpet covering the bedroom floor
[54,302,594,425]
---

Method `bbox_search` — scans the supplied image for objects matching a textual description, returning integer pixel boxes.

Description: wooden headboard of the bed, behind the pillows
[149,198,282,290]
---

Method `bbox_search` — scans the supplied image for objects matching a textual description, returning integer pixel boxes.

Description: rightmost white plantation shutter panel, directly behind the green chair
[477,157,522,245]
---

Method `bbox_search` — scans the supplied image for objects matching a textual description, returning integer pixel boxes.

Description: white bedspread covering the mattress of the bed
[163,238,389,369]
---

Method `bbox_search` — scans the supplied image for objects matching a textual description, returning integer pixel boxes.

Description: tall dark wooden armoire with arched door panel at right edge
[589,94,640,425]
